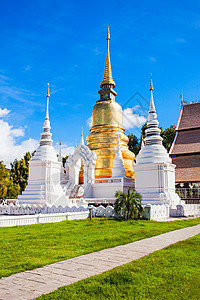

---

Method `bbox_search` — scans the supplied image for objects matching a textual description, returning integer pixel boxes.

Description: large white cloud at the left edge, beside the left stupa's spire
[0,108,38,168]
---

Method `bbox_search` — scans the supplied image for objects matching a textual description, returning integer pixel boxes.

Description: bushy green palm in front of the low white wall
[114,188,143,220]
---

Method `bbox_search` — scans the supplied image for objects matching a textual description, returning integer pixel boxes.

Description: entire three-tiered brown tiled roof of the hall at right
[170,102,200,182]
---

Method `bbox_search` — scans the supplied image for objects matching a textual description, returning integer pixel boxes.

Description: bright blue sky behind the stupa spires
[0,0,200,164]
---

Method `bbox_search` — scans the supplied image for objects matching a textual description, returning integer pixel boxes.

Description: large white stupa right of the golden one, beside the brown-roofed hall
[134,79,180,208]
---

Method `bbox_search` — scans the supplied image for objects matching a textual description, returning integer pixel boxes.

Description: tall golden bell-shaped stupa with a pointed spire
[86,28,135,178]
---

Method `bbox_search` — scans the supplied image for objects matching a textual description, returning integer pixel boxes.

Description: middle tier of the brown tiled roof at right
[171,128,200,155]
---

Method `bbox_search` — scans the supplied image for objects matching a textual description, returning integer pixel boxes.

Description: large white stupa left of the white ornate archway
[18,86,67,206]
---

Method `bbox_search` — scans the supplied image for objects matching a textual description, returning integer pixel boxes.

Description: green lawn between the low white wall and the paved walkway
[0,218,200,277]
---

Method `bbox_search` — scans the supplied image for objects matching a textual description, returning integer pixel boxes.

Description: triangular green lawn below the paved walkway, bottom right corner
[37,235,200,300]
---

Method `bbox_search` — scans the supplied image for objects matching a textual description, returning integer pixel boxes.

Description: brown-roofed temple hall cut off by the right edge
[170,97,200,203]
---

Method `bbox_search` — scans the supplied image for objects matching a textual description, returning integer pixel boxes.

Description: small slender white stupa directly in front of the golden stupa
[112,129,125,178]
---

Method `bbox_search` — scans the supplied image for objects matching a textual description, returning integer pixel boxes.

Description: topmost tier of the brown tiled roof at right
[177,102,200,130]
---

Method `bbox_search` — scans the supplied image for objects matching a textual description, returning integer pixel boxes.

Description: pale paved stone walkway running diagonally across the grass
[0,225,200,300]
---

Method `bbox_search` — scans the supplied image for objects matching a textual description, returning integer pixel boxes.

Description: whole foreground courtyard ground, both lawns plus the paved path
[0,218,200,299]
